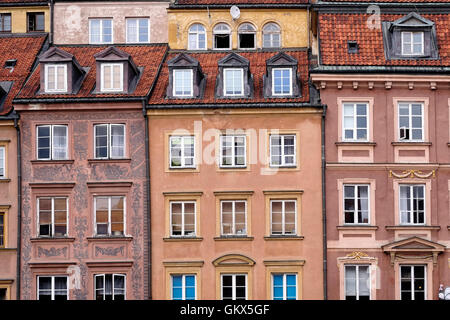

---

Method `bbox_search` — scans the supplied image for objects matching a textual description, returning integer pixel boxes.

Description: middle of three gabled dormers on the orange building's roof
[216,52,254,98]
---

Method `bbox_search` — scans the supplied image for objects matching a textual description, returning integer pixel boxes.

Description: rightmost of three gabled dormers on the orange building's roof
[263,52,301,98]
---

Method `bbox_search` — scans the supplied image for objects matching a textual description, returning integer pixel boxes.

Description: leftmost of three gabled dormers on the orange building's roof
[166,53,206,99]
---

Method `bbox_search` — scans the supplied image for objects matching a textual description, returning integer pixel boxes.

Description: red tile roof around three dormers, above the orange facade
[149,50,309,105]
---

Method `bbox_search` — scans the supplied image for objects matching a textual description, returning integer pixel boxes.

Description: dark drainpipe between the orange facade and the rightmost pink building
[322,105,328,300]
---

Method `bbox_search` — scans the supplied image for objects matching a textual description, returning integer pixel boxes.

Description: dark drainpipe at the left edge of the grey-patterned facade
[14,117,22,300]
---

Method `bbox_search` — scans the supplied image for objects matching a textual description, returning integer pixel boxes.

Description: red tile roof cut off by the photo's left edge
[0,35,46,115]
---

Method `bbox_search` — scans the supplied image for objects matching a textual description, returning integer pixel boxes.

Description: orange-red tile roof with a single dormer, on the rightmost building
[319,13,450,66]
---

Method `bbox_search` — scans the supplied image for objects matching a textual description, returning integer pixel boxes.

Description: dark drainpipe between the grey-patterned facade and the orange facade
[142,99,152,300]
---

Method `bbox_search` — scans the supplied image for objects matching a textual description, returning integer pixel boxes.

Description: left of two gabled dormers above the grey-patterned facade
[39,47,86,94]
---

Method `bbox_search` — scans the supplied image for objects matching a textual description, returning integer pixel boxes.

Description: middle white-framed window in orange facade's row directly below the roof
[220,135,246,168]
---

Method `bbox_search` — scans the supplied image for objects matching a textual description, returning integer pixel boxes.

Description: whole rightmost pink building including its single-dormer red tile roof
[311,2,450,300]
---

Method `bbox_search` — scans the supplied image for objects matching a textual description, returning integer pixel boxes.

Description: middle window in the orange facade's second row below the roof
[220,200,247,236]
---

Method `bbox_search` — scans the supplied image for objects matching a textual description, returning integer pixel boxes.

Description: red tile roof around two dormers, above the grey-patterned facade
[17,44,167,99]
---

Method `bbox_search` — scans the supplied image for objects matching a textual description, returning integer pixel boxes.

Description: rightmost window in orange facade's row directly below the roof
[270,134,296,167]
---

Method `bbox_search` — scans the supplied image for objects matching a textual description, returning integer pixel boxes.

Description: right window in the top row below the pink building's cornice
[398,102,424,141]
